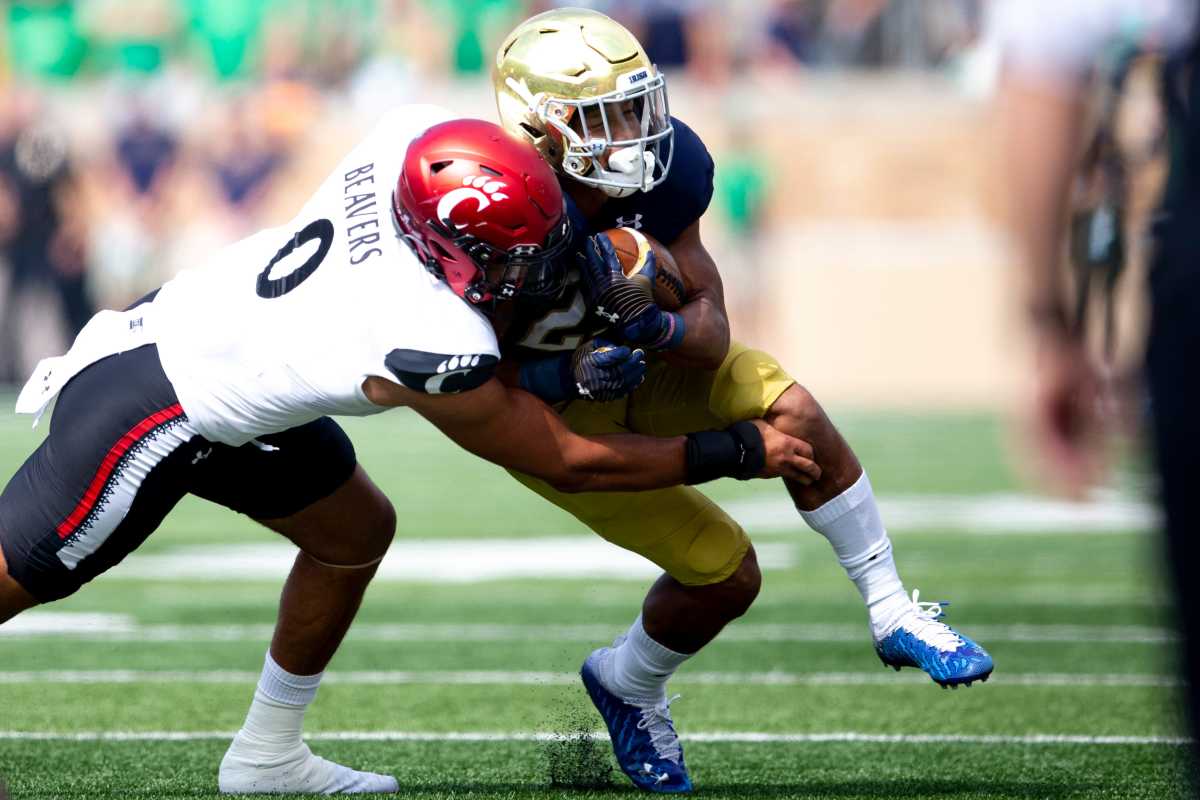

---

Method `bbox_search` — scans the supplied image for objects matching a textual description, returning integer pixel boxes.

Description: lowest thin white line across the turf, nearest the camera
[0,730,1192,746]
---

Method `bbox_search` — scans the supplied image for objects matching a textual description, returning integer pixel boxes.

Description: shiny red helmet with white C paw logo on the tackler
[391,119,571,305]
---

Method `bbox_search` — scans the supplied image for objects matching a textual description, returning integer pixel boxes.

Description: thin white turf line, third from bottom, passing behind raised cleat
[0,610,1177,644]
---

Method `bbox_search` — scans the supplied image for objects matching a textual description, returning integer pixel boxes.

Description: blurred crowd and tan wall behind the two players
[0,0,1128,404]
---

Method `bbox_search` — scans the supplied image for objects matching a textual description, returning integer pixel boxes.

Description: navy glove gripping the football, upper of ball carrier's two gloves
[578,234,684,350]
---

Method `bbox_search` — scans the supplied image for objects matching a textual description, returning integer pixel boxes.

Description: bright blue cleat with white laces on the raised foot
[875,590,992,688]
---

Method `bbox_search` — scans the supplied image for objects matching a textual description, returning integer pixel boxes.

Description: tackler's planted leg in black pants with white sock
[192,419,398,794]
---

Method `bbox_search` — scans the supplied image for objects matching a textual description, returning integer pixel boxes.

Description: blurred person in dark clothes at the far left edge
[0,92,94,381]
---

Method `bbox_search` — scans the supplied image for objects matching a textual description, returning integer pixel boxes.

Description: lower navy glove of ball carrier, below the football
[520,339,646,403]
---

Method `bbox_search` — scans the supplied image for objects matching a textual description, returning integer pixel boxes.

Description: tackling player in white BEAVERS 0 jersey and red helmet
[0,107,820,793]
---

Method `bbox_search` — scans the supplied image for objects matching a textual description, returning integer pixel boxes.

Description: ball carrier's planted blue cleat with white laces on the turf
[580,648,691,794]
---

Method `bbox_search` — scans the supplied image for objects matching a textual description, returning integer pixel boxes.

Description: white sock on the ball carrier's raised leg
[800,471,912,638]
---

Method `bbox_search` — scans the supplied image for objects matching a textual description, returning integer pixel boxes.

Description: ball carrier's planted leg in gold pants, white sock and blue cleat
[514,393,761,792]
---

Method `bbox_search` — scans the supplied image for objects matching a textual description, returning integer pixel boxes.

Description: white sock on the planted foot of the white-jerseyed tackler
[217,652,400,794]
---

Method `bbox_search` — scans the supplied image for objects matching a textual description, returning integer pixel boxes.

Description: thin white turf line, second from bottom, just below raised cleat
[0,668,1182,688]
